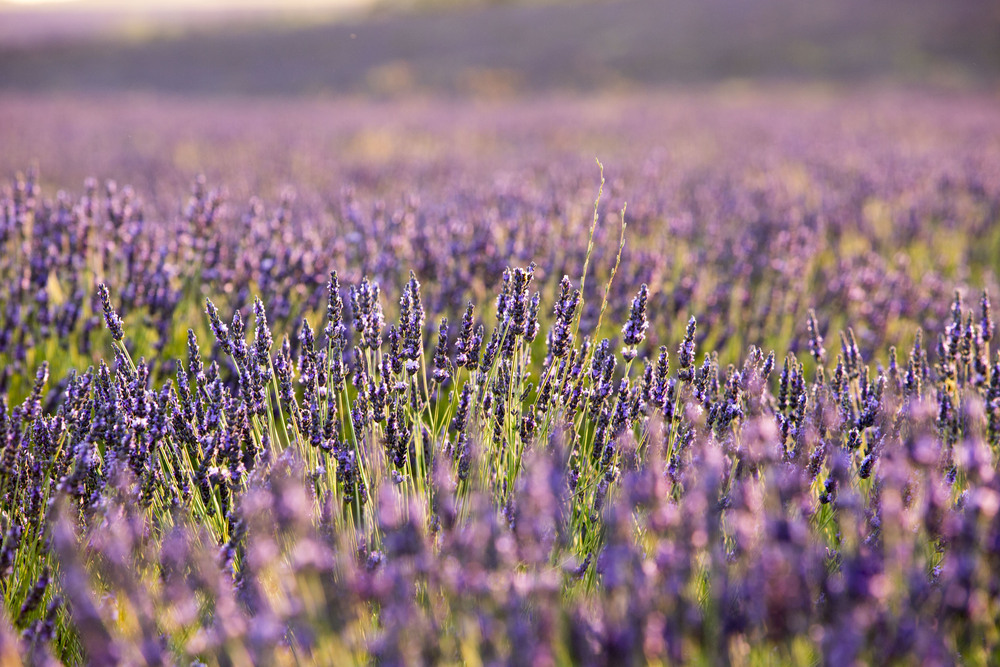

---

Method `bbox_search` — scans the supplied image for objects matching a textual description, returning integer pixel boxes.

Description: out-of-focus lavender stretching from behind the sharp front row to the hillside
[0,91,1000,396]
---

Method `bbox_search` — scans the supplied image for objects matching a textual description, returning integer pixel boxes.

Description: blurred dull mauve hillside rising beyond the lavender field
[0,0,1000,95]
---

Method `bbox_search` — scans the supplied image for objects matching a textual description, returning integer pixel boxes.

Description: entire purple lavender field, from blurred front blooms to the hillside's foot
[0,84,1000,665]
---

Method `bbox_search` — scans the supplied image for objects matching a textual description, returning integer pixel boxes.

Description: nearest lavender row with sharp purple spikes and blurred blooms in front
[0,249,1000,664]
